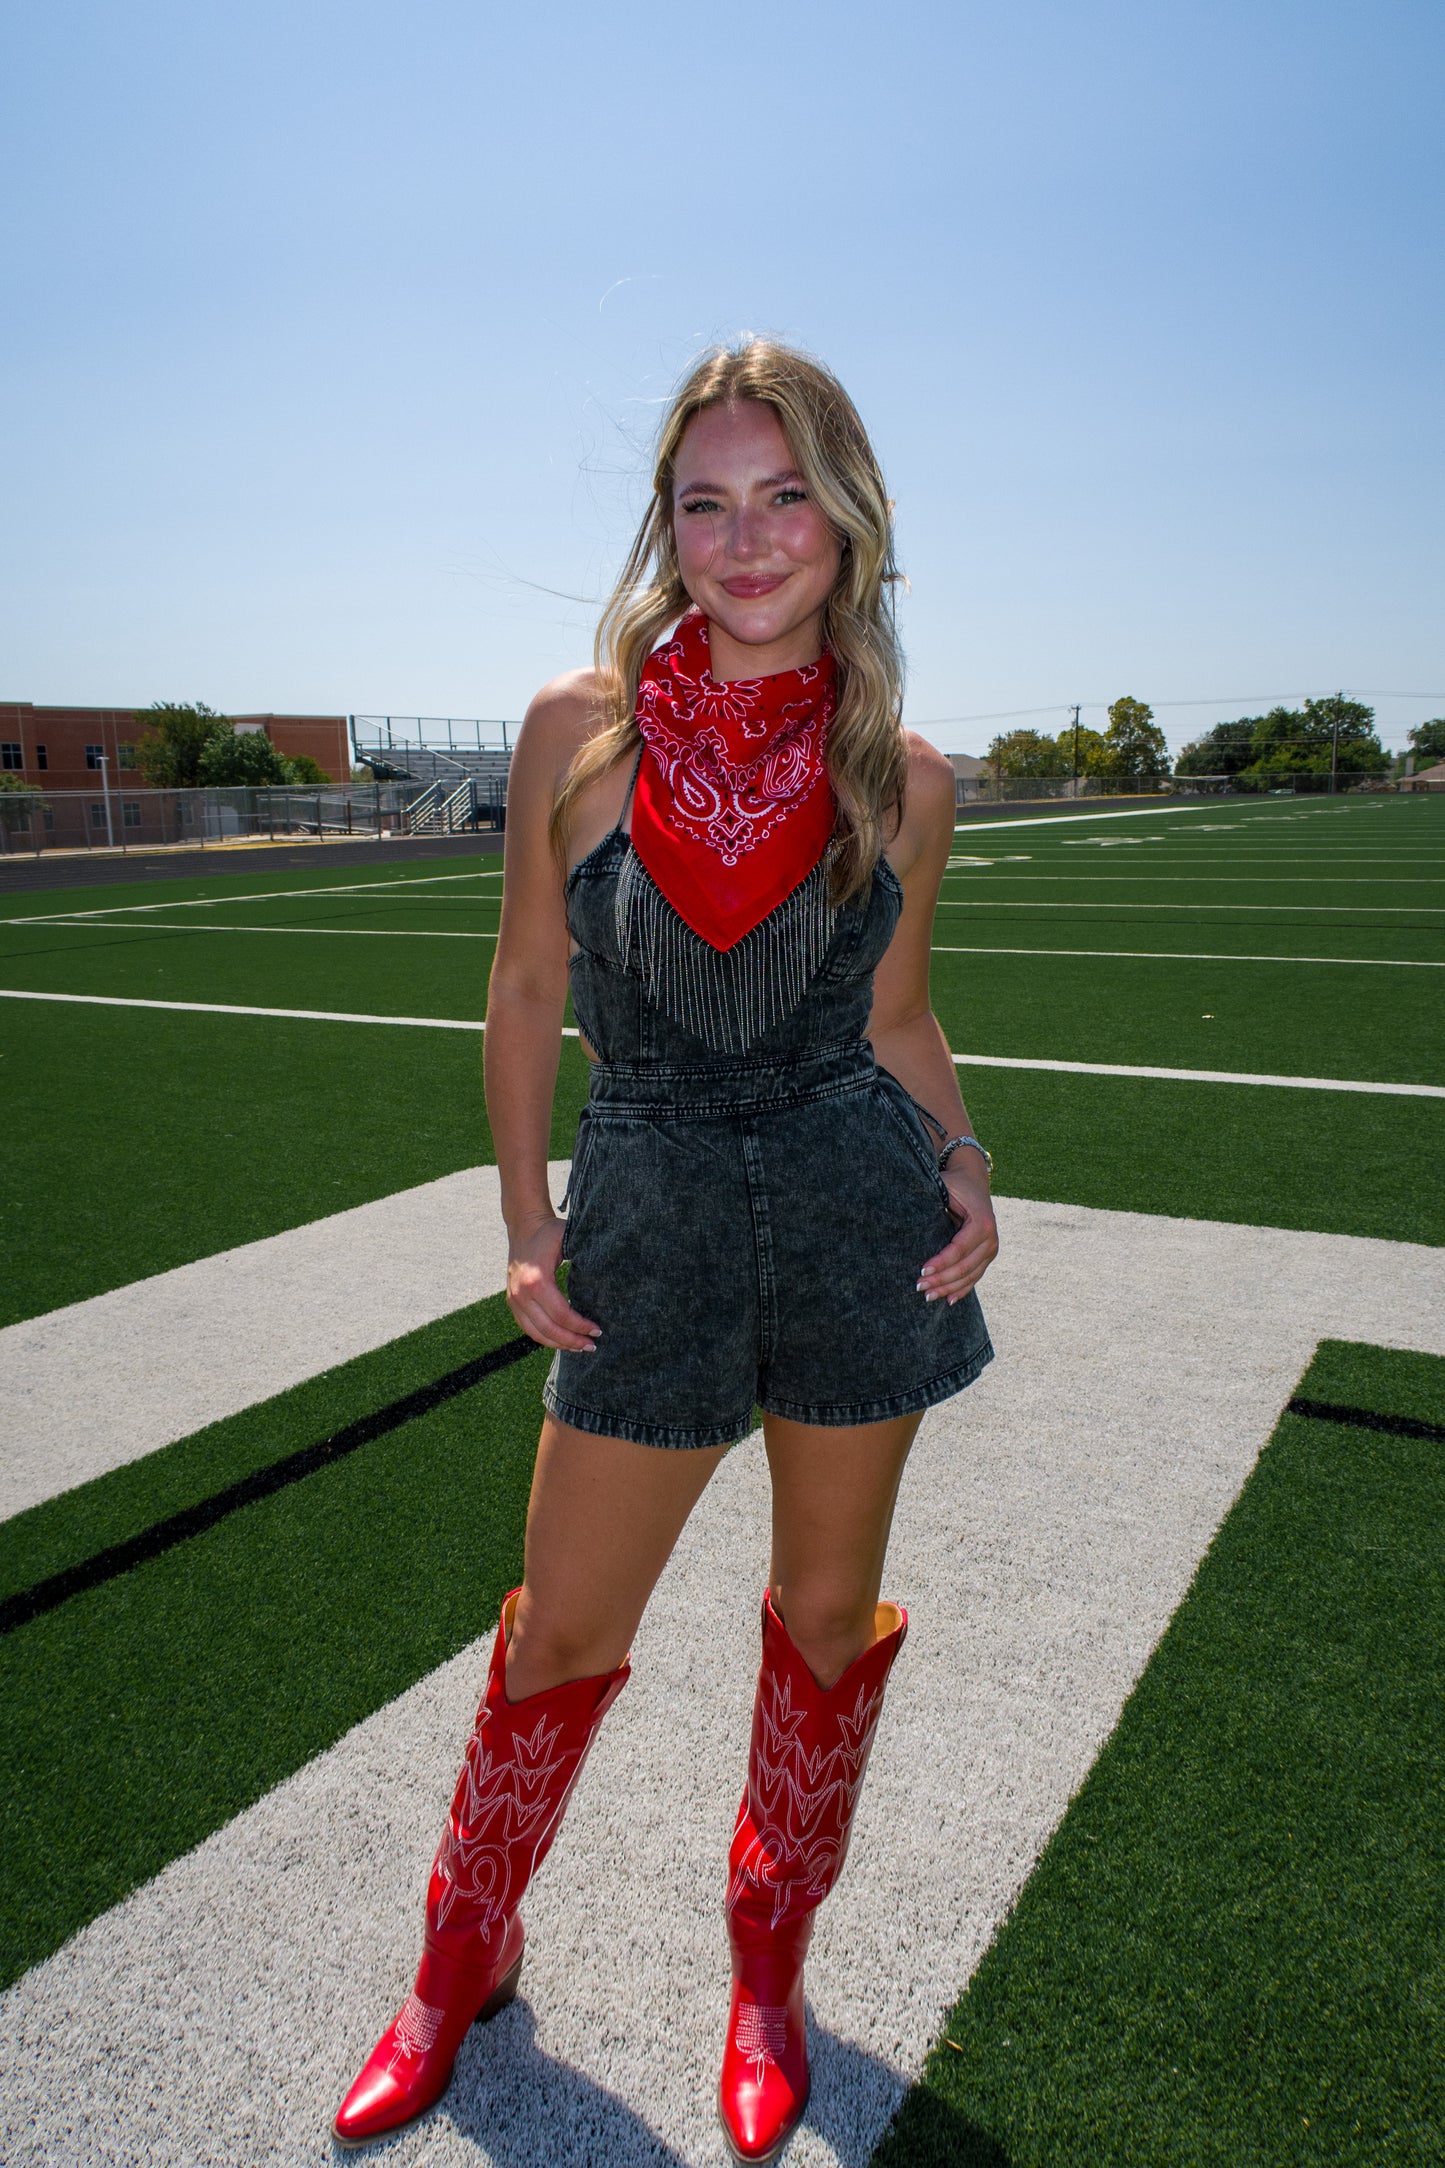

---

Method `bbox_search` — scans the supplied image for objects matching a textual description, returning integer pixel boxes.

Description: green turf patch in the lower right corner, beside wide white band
[873,1342,1445,2168]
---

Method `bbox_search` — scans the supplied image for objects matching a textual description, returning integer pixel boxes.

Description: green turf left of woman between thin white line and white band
[0,1002,587,1318]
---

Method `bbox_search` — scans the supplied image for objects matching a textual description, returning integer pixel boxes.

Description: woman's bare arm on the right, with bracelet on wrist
[869,737,999,1303]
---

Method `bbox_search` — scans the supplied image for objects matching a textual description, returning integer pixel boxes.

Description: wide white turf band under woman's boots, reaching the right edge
[0,1199,1445,2168]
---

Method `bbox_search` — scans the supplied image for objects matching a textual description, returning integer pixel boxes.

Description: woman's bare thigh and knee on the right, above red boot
[763,1416,921,1687]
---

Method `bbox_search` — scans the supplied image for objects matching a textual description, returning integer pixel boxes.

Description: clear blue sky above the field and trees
[0,0,1445,750]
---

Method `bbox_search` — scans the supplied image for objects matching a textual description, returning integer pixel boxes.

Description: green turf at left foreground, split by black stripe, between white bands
[0,1299,546,1986]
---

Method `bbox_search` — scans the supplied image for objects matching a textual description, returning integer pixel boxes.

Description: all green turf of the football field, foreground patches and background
[0,798,1445,2168]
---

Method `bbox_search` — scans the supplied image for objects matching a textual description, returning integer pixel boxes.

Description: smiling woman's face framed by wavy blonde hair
[672,399,843,679]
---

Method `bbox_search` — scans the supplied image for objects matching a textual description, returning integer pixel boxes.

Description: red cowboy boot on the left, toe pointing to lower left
[334,1589,628,2146]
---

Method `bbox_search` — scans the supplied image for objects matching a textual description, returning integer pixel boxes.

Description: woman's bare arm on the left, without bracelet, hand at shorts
[485,672,598,1351]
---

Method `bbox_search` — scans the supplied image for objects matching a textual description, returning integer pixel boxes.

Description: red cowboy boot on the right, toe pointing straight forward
[717,1593,908,2164]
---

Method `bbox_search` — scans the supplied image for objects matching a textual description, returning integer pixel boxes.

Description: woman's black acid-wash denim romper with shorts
[546,828,992,1446]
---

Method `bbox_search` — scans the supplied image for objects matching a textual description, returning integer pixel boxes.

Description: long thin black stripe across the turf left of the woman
[0,1335,539,1635]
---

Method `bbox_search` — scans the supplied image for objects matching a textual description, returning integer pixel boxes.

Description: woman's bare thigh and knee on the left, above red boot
[507,1416,728,1702]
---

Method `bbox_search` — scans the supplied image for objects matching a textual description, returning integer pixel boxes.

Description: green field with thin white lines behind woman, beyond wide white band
[0,798,1445,1320]
